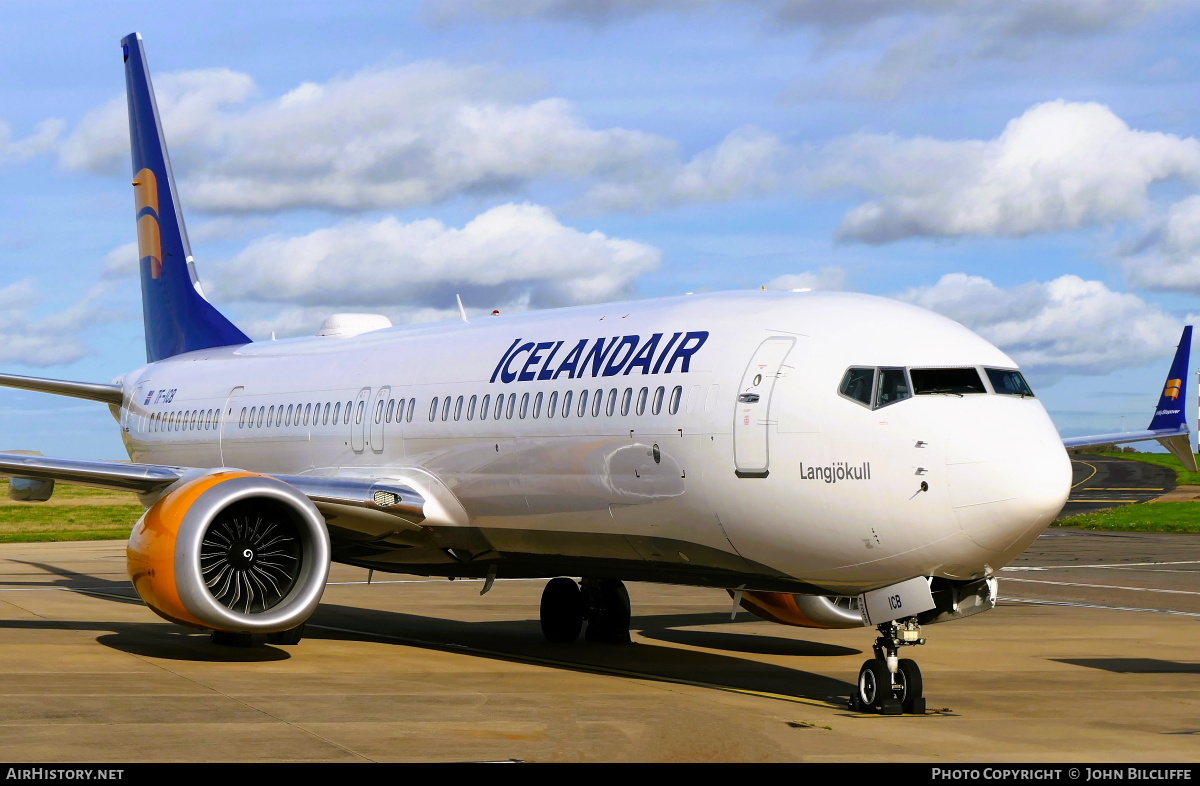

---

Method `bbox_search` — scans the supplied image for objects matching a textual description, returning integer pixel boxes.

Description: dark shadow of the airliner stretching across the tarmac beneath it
[0,562,860,703]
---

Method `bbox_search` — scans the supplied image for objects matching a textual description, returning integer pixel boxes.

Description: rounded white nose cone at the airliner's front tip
[946,396,1070,566]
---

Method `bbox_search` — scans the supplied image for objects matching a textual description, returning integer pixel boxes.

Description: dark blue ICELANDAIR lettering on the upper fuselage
[491,330,708,384]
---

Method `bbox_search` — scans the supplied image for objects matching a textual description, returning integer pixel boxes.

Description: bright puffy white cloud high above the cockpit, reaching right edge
[811,101,1200,244]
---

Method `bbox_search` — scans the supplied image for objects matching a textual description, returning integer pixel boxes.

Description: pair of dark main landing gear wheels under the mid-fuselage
[541,577,630,644]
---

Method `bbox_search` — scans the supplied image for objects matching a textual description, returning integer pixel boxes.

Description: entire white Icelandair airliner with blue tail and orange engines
[0,35,1194,712]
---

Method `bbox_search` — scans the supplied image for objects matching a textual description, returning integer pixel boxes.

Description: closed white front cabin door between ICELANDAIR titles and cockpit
[733,336,796,478]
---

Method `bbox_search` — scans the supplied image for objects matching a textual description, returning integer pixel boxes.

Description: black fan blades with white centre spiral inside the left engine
[200,510,301,614]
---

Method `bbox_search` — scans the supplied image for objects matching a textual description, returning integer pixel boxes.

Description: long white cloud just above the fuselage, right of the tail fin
[215,204,660,311]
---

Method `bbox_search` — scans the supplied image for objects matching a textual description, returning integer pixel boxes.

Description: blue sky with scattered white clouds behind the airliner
[0,0,1200,458]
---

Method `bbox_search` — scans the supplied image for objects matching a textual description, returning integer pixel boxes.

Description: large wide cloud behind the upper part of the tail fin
[61,61,683,211]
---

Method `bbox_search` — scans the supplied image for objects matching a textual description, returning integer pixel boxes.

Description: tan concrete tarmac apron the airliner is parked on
[0,529,1200,763]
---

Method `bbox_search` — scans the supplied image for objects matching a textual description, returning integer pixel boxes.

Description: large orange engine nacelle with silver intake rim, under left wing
[126,472,330,634]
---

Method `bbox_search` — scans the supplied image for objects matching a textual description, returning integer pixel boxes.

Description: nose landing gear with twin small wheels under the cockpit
[850,617,925,715]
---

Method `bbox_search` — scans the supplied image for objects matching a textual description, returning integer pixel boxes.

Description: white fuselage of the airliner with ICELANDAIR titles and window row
[120,292,1070,594]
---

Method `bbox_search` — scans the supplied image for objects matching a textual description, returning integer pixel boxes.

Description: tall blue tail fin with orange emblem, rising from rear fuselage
[121,32,250,362]
